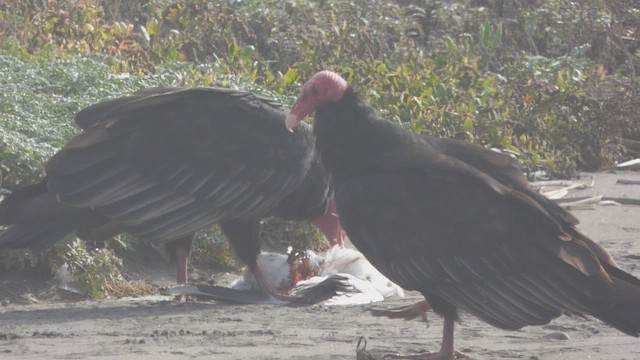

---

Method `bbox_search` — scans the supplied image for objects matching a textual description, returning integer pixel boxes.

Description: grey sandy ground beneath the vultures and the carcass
[0,172,640,360]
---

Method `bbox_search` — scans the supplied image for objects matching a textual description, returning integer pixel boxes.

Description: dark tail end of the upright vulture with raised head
[593,265,640,337]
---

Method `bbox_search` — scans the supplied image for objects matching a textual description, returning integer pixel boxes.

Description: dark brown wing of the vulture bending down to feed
[45,88,312,241]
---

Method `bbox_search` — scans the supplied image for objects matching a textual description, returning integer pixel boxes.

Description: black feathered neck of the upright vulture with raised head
[314,87,411,183]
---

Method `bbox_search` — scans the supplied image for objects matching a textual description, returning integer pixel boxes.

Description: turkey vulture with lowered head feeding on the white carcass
[0,88,344,298]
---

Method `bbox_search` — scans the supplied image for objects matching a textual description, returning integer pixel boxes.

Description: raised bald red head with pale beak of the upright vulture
[285,70,348,130]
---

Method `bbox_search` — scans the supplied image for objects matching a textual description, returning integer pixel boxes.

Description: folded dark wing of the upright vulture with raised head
[336,146,615,329]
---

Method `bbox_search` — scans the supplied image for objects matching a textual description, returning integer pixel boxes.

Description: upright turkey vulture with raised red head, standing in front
[286,71,640,359]
